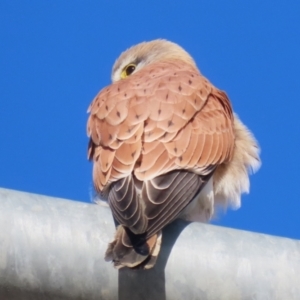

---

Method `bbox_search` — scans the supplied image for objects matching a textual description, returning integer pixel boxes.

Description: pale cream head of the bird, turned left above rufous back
[111,39,196,82]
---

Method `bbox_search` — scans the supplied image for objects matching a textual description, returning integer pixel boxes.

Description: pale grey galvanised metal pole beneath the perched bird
[0,189,300,300]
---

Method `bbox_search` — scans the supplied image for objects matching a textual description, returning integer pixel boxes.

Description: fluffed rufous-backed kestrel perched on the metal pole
[87,40,260,269]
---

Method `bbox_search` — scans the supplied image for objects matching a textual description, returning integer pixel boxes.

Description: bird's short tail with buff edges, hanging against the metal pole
[105,225,162,269]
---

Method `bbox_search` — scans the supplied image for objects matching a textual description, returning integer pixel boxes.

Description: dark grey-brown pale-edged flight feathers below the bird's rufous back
[108,170,212,238]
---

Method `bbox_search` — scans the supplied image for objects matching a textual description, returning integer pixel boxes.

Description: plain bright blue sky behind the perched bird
[0,0,300,239]
